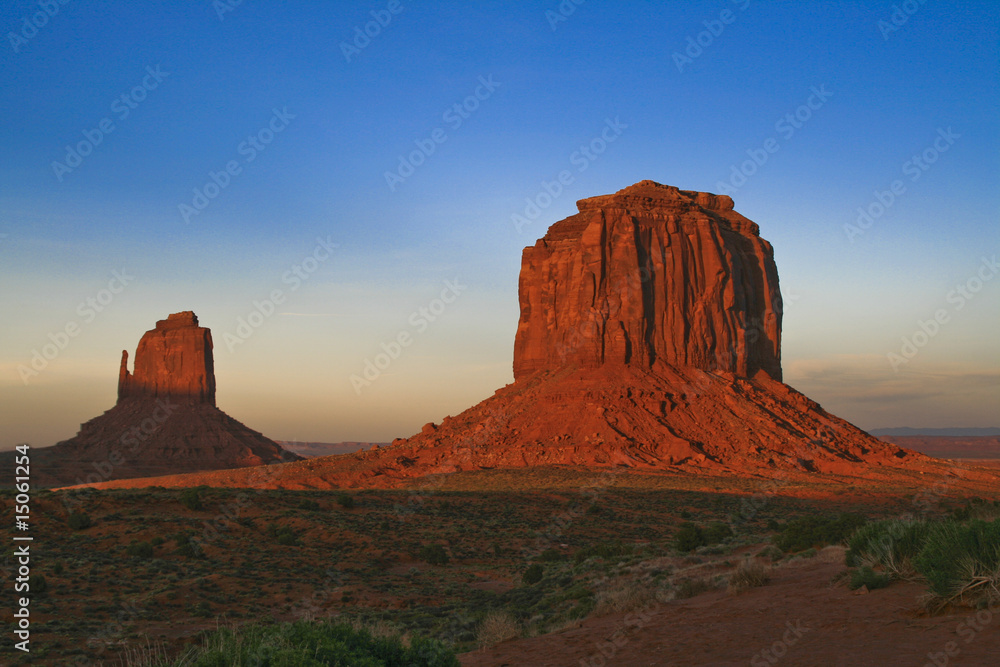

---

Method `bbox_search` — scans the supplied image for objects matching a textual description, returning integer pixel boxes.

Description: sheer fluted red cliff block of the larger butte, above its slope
[514,181,781,380]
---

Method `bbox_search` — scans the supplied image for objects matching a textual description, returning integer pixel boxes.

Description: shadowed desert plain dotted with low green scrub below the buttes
[0,480,995,666]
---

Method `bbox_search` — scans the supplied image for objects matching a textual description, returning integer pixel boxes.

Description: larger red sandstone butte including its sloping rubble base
[292,181,924,486]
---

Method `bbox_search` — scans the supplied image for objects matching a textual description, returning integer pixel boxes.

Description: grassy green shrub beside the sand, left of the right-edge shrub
[846,519,929,579]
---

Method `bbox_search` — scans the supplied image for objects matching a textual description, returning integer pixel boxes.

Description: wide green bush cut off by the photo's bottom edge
[174,621,459,667]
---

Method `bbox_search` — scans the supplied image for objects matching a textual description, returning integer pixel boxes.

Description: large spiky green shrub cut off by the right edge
[914,519,1000,601]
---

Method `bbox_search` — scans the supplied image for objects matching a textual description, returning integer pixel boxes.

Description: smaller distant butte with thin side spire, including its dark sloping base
[23,311,301,486]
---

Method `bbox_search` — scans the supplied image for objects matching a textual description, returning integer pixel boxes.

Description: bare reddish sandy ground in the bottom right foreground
[461,548,1000,667]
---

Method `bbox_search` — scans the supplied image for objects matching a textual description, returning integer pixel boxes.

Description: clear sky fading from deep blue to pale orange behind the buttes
[0,0,1000,447]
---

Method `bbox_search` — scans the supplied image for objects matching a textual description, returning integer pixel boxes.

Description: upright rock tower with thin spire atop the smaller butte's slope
[118,310,215,405]
